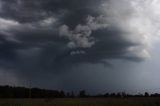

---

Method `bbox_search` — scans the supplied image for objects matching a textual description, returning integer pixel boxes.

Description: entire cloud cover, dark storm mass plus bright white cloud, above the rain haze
[0,0,160,85]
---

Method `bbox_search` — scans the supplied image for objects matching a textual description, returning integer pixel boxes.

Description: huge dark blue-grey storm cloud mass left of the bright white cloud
[0,0,151,84]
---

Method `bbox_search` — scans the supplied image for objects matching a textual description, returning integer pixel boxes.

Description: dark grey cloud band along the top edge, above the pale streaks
[1,0,101,24]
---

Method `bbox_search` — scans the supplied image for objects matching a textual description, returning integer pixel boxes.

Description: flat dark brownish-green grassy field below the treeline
[0,97,160,106]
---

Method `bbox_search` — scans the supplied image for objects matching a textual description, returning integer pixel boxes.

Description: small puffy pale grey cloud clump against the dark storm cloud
[59,16,107,48]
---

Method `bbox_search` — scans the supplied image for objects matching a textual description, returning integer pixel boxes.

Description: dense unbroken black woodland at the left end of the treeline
[0,86,65,98]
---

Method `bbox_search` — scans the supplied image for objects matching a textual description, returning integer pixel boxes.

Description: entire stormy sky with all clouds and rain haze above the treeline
[0,0,160,93]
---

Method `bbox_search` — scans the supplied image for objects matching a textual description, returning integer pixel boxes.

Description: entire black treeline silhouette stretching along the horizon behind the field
[0,86,160,98]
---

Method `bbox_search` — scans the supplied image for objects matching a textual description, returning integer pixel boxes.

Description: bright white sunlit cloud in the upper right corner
[103,0,160,58]
